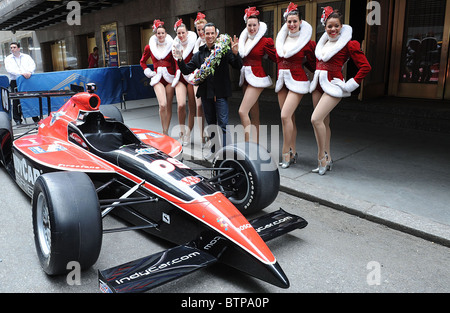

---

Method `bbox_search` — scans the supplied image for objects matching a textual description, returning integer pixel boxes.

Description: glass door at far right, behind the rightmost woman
[389,0,450,99]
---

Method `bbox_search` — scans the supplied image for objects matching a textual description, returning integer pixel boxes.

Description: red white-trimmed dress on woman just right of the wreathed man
[239,22,277,88]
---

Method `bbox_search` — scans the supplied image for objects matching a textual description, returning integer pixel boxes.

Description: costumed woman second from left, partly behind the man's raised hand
[172,19,197,146]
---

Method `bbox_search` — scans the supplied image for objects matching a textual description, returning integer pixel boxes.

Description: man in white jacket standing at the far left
[5,42,39,124]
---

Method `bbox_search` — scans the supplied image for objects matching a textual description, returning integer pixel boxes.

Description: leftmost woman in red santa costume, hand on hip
[140,20,175,135]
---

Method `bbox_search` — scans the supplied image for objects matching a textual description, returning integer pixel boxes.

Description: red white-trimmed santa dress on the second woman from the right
[275,21,316,94]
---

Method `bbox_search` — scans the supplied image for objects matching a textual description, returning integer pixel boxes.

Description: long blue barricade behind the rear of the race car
[17,65,155,117]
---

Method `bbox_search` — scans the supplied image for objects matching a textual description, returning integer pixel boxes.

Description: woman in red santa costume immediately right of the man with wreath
[239,7,277,142]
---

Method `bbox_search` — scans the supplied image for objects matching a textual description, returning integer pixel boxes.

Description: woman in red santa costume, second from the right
[275,3,316,168]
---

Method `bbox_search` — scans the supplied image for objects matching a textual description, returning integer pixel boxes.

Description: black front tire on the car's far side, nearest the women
[213,142,280,215]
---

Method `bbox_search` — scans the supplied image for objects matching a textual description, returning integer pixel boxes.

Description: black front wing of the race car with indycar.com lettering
[98,209,308,293]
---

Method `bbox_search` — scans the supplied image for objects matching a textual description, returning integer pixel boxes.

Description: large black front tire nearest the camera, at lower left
[32,172,103,275]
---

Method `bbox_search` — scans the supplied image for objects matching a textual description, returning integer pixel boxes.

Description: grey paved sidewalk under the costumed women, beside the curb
[116,93,450,246]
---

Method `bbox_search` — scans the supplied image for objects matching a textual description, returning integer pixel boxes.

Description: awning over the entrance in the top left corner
[0,0,123,30]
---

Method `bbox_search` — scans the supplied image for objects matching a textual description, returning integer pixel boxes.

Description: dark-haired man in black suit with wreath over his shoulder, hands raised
[174,23,242,159]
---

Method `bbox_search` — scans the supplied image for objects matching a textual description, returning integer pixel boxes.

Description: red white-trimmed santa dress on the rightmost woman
[310,25,371,98]
